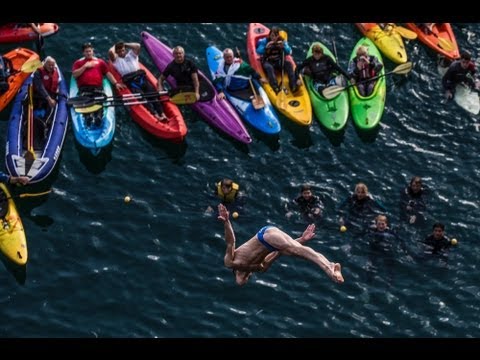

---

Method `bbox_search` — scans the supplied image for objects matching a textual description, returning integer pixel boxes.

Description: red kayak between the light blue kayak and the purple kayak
[109,61,187,142]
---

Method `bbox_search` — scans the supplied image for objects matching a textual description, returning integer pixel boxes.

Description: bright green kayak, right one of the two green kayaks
[348,37,387,130]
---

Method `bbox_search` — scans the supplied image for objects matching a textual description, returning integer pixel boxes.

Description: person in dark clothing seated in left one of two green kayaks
[296,44,349,93]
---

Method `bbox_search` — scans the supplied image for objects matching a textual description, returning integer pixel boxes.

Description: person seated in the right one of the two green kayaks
[348,46,383,97]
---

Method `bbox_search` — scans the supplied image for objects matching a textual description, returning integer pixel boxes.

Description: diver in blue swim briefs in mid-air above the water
[218,204,344,285]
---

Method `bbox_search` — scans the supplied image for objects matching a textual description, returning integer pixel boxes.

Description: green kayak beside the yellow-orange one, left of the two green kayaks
[304,41,348,131]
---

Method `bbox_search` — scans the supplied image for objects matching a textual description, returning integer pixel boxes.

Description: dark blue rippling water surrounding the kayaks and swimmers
[0,23,480,337]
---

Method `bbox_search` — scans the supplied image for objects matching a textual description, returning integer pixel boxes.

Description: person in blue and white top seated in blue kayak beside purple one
[213,48,267,99]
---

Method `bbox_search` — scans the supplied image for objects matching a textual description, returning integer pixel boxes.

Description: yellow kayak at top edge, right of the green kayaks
[355,23,407,64]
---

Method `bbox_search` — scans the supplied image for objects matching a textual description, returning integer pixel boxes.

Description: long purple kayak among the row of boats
[142,31,252,144]
